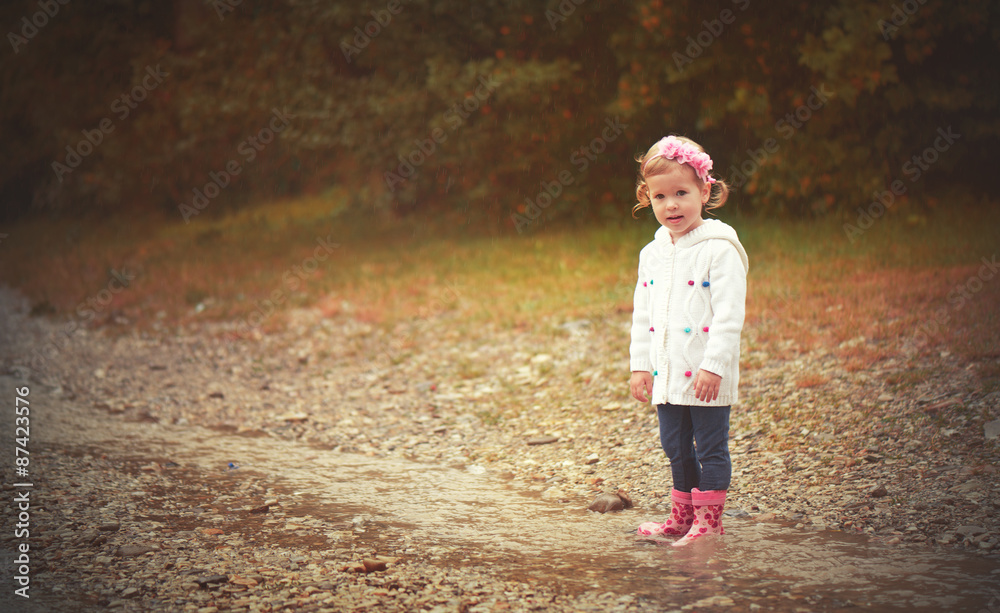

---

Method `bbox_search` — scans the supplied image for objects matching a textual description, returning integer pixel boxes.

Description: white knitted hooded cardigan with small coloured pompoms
[629,219,750,406]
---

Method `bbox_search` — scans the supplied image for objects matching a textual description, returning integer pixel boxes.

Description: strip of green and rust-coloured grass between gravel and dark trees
[0,198,1000,376]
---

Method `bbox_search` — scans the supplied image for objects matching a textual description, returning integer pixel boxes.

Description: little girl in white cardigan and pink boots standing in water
[629,136,749,546]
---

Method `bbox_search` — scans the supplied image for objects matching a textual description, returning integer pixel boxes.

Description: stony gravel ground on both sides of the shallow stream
[0,290,1000,613]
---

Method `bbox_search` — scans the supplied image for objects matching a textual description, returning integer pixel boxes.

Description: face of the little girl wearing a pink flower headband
[646,164,712,241]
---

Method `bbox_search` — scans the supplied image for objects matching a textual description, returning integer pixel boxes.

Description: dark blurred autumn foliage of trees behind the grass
[0,0,1000,230]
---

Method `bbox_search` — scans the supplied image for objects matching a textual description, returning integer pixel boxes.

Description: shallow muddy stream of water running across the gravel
[13,380,1000,612]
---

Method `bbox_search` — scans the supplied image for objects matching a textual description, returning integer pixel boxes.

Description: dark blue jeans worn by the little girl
[656,404,733,492]
